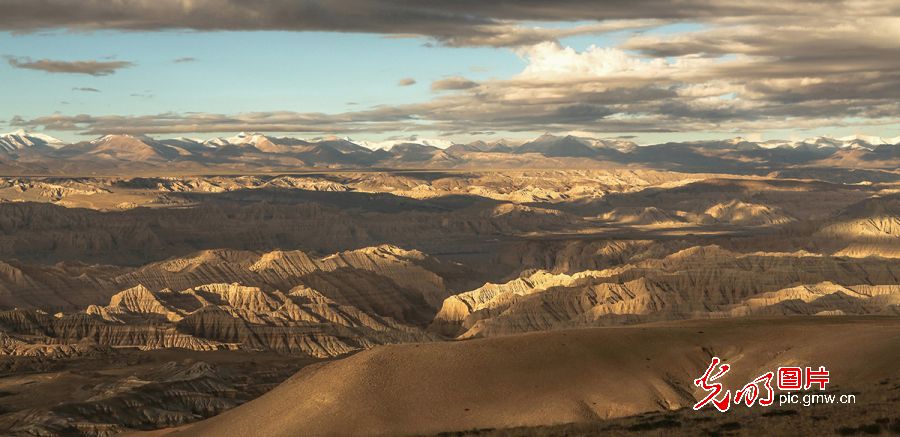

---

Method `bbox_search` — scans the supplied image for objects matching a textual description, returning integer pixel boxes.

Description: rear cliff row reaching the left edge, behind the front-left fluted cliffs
[0,245,470,324]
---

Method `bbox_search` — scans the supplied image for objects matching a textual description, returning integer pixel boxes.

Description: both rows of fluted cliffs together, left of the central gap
[0,246,464,358]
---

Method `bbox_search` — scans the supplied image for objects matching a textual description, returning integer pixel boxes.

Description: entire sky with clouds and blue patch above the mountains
[0,0,900,143]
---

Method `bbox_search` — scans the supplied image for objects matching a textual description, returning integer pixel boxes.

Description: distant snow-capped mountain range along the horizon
[0,130,900,174]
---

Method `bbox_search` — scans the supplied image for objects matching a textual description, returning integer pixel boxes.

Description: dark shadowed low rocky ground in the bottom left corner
[0,348,310,436]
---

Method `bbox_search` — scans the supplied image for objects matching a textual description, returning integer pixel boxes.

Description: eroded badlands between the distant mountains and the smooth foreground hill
[0,170,900,435]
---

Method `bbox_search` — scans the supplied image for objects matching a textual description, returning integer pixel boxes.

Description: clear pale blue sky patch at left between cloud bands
[0,31,524,136]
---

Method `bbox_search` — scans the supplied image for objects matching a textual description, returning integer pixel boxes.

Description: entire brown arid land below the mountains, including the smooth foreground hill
[0,162,900,435]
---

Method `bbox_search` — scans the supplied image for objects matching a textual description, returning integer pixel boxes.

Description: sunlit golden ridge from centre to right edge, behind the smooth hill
[432,246,900,338]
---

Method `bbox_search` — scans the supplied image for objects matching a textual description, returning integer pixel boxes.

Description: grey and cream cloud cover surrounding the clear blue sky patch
[7,0,900,134]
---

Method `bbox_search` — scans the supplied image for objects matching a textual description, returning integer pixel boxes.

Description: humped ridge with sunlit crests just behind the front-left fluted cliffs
[116,245,454,324]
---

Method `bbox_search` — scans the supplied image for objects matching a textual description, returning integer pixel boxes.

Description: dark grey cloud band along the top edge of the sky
[0,0,828,46]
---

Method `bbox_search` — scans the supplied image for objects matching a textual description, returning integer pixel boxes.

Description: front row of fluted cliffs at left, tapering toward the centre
[0,283,434,358]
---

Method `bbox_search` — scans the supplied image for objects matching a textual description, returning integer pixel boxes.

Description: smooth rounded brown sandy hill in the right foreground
[179,318,900,436]
